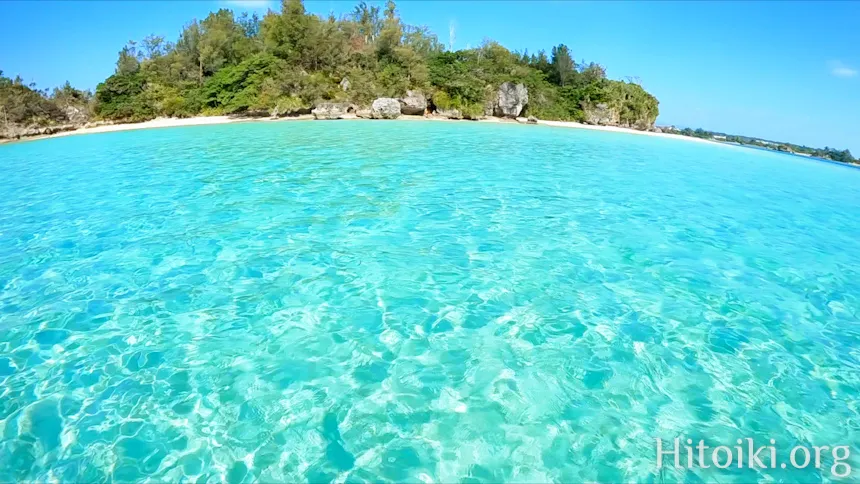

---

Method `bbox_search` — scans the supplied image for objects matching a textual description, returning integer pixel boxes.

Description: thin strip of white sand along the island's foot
[0,114,732,146]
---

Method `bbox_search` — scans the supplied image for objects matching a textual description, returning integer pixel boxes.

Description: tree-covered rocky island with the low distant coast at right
[0,0,856,163]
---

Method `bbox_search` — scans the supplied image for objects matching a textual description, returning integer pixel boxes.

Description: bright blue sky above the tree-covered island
[0,0,860,152]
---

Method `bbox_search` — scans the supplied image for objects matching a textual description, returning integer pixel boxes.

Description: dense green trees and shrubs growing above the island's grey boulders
[3,0,659,129]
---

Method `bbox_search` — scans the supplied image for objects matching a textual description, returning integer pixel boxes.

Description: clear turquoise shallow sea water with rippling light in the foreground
[0,121,860,482]
